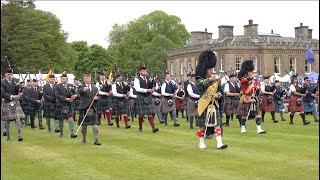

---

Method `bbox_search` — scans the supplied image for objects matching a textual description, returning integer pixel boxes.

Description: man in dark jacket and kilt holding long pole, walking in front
[78,73,101,145]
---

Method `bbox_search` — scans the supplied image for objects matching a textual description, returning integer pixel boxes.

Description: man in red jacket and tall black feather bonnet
[238,60,267,134]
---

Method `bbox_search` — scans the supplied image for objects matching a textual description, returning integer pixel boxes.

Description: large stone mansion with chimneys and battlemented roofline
[167,20,319,81]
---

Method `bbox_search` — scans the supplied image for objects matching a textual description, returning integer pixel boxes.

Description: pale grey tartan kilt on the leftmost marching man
[1,101,26,121]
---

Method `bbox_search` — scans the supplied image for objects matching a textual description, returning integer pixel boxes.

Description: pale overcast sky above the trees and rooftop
[35,1,319,47]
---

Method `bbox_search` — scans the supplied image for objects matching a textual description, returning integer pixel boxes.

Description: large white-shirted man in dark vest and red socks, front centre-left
[134,62,159,133]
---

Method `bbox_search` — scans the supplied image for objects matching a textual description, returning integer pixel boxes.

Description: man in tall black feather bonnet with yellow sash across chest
[195,50,228,149]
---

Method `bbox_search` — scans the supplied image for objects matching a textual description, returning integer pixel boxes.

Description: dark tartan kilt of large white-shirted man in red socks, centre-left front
[135,95,155,115]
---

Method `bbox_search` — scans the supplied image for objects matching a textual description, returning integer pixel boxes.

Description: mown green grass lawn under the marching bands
[1,113,319,180]
